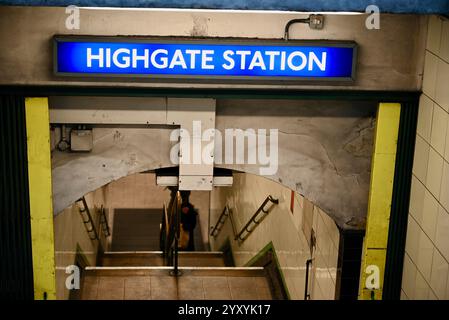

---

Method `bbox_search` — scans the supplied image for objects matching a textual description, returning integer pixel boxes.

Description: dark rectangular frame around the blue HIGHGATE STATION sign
[52,35,358,85]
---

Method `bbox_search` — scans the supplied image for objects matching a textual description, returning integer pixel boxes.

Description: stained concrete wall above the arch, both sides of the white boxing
[52,99,377,229]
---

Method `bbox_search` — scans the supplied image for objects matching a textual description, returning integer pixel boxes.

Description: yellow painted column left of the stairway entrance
[25,98,56,300]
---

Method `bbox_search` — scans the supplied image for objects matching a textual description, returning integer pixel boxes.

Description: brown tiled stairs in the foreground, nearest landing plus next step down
[81,251,272,300]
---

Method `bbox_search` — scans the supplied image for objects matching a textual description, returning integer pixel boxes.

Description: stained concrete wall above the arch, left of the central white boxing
[52,127,172,214]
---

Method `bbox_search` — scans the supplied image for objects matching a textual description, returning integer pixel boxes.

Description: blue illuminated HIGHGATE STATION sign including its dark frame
[54,37,357,81]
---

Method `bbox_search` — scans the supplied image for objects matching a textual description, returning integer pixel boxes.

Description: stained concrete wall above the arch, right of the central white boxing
[216,99,377,229]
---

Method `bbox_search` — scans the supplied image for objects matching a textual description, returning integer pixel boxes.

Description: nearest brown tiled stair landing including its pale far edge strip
[81,267,272,300]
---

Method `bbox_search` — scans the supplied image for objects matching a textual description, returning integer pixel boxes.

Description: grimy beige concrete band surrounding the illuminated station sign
[0,7,427,90]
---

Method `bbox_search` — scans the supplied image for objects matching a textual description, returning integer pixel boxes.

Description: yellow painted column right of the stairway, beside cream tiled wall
[359,103,401,300]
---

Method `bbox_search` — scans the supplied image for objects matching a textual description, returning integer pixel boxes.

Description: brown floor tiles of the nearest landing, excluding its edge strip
[82,276,272,300]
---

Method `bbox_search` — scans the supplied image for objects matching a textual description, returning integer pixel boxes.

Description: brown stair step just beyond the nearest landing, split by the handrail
[101,251,225,267]
